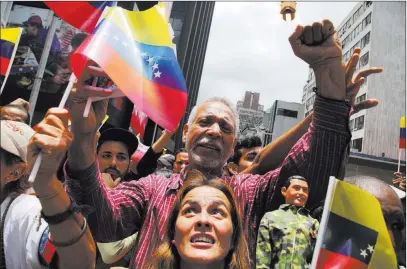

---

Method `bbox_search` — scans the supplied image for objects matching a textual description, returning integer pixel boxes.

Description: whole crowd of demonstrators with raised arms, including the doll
[0,17,405,269]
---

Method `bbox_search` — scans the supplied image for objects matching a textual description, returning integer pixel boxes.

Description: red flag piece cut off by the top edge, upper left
[44,1,117,33]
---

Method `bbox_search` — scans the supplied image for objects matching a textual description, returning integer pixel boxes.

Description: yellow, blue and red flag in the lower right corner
[314,178,397,269]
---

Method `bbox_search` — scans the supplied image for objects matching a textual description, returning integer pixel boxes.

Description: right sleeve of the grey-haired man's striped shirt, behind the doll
[254,95,351,210]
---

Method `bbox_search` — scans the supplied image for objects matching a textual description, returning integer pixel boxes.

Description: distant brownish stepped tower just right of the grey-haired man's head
[236,91,264,133]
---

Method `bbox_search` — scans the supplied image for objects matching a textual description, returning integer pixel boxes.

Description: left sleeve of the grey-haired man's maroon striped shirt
[65,161,154,243]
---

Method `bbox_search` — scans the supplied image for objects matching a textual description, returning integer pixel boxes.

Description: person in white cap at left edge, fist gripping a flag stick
[0,113,96,269]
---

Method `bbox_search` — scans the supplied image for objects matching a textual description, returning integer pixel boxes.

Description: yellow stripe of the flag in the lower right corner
[330,180,397,269]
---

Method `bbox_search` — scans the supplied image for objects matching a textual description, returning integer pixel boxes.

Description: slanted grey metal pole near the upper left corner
[30,10,59,124]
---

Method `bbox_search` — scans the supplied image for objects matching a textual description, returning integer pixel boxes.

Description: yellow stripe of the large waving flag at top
[103,6,172,48]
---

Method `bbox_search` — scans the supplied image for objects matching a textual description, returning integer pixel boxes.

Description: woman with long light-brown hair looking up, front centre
[148,170,249,269]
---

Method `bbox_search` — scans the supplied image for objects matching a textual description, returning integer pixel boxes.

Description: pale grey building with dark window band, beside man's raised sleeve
[263,100,304,145]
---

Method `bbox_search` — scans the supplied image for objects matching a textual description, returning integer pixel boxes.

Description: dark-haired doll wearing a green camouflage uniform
[256,176,319,269]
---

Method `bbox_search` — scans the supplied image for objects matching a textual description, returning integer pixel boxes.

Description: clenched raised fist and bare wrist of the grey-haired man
[289,20,346,100]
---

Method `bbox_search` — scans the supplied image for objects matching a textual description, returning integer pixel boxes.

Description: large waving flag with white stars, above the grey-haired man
[71,6,187,131]
